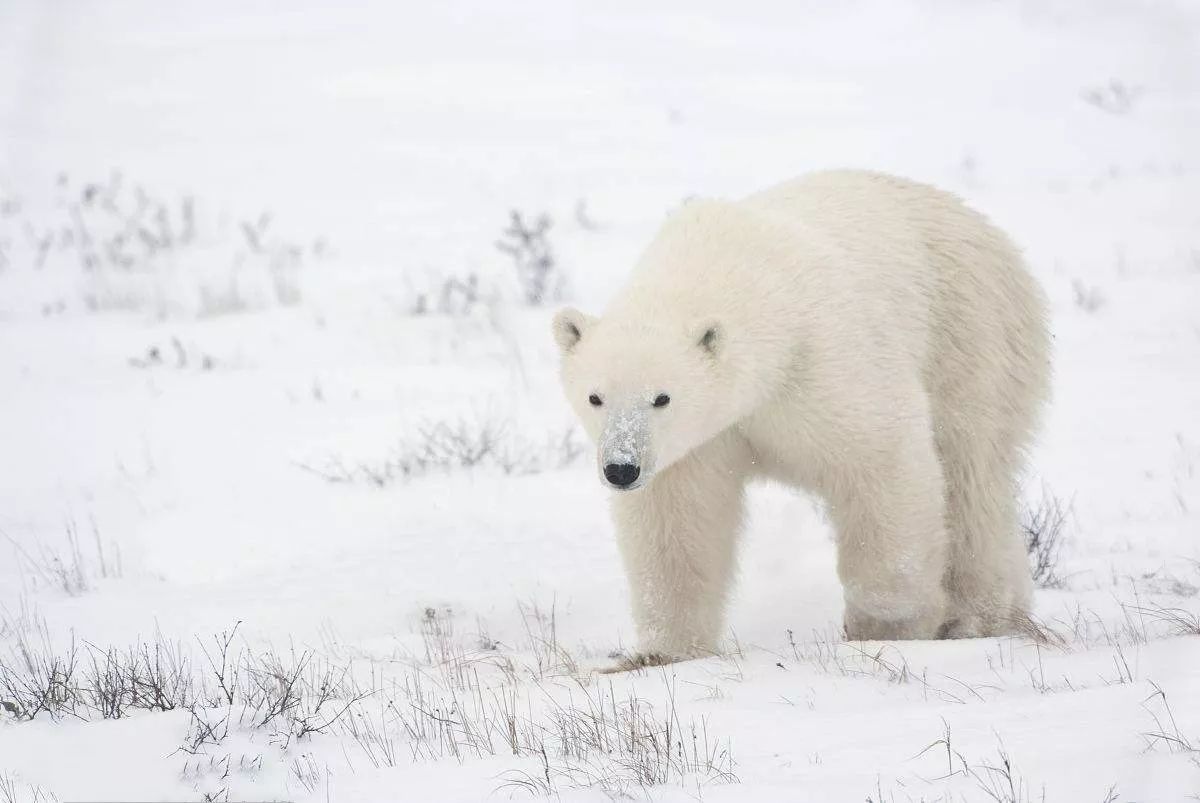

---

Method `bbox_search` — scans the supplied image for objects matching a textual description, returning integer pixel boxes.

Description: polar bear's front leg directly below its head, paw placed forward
[612,436,746,666]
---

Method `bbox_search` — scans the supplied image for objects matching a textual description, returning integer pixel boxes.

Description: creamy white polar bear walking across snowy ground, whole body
[553,165,1049,664]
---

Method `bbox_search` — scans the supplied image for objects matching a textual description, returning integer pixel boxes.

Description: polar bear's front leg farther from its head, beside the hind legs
[830,426,948,641]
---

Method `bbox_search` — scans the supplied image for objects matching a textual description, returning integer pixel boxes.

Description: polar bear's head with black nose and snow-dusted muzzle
[554,308,728,491]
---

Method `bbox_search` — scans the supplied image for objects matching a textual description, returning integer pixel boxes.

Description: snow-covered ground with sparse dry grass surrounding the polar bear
[0,0,1200,803]
